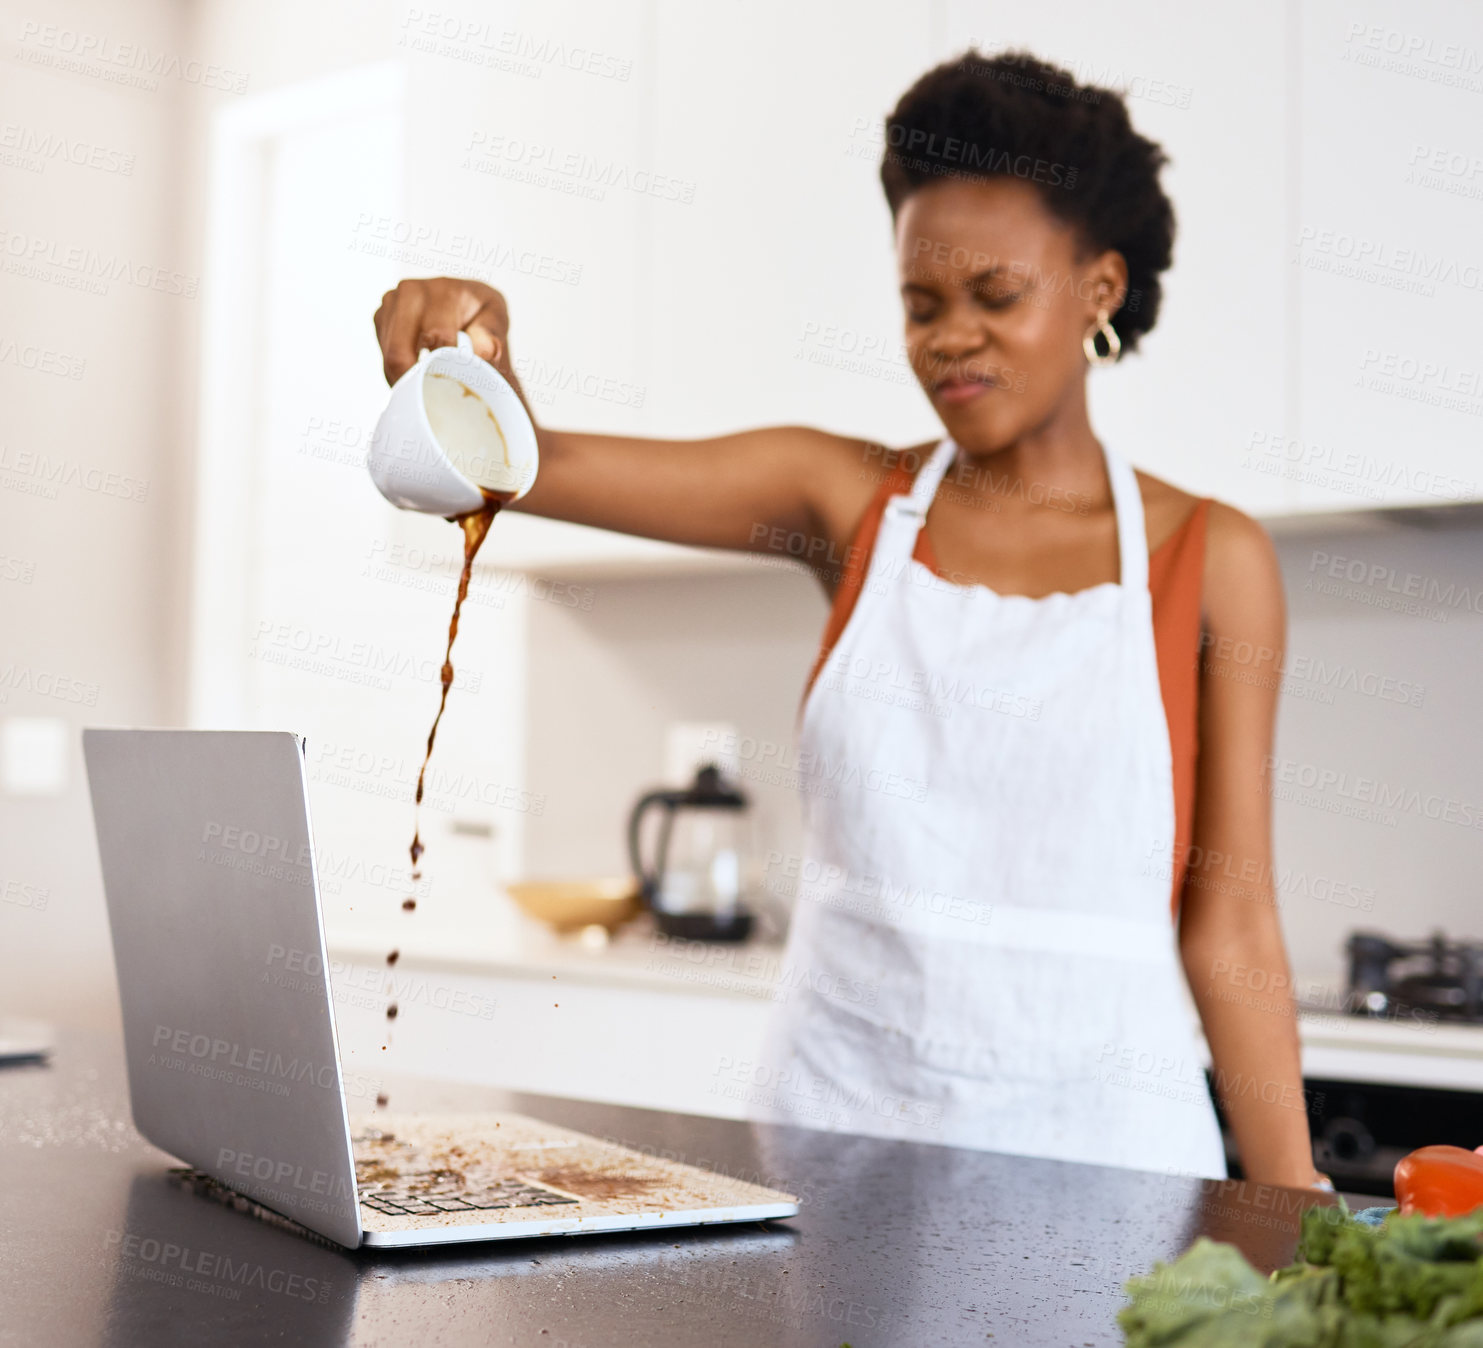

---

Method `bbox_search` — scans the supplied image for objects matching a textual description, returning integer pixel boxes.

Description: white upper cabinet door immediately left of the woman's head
[642,0,936,445]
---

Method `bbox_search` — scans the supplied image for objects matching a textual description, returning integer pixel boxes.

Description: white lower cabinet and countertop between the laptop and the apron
[332,933,780,1118]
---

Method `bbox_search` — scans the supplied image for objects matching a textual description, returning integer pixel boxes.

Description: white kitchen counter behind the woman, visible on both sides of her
[331,924,1483,1118]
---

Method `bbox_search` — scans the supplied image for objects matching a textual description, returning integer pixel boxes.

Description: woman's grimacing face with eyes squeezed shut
[896,178,1127,455]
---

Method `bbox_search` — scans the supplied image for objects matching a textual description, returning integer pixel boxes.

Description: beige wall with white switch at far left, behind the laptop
[0,0,194,1019]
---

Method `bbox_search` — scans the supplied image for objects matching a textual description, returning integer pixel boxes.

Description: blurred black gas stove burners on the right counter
[1345,931,1483,1025]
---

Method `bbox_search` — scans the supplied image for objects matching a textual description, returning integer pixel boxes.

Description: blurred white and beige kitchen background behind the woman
[0,0,1483,1180]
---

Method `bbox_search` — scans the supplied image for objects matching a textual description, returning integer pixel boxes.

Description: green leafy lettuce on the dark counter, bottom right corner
[1118,1204,1483,1348]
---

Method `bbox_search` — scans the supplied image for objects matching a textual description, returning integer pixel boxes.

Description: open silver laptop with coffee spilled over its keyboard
[83,730,798,1247]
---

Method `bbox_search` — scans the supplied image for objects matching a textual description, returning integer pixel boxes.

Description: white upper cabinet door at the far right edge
[1284,0,1483,509]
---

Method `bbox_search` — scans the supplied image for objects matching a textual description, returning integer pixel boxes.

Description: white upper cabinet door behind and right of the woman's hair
[942,0,1293,513]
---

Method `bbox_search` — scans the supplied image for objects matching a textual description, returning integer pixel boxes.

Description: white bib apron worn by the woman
[746,439,1226,1179]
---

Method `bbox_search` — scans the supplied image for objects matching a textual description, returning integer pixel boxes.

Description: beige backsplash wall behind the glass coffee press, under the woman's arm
[525,568,828,901]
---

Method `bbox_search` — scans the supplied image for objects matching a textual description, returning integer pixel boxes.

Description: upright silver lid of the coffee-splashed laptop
[83,730,360,1246]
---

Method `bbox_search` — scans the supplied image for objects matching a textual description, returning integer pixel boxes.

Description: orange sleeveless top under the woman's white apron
[804,464,1212,916]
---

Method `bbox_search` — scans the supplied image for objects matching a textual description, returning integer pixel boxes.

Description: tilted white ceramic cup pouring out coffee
[366,332,538,518]
